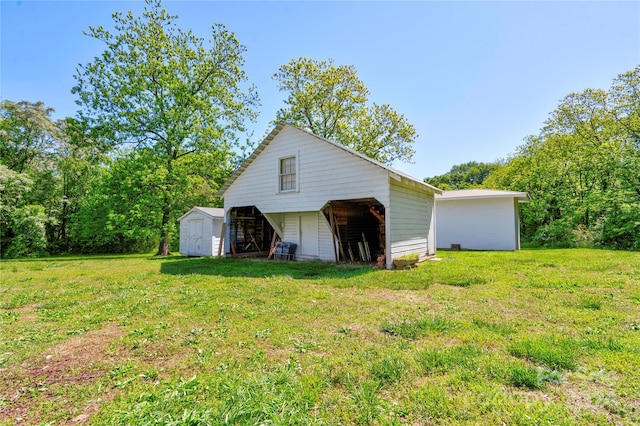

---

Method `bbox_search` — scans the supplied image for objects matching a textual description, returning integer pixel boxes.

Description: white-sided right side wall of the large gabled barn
[389,180,435,259]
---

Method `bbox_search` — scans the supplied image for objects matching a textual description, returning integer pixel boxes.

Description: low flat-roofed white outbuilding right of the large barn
[436,189,529,250]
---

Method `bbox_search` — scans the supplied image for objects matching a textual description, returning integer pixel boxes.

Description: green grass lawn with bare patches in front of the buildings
[0,250,640,425]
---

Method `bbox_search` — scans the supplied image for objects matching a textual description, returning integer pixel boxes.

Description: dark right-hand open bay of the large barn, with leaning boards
[323,198,386,262]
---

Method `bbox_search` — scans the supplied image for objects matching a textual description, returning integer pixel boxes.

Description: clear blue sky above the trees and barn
[0,0,640,179]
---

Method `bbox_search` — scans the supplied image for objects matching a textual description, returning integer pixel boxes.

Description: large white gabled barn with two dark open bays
[218,123,442,268]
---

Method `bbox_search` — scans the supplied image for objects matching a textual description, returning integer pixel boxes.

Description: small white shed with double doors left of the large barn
[178,207,224,256]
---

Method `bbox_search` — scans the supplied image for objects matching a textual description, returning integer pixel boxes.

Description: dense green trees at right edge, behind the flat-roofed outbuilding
[485,67,640,249]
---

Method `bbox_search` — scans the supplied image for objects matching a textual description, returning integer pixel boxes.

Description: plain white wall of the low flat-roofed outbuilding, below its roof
[437,198,518,250]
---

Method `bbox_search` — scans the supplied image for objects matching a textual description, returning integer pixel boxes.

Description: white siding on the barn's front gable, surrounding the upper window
[224,127,388,213]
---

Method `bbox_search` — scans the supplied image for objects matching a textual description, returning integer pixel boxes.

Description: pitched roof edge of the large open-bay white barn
[216,122,442,197]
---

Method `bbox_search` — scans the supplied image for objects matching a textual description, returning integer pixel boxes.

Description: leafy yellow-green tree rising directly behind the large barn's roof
[273,58,418,164]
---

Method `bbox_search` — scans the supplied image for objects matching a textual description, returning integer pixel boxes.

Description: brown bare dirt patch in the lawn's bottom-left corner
[0,324,122,424]
